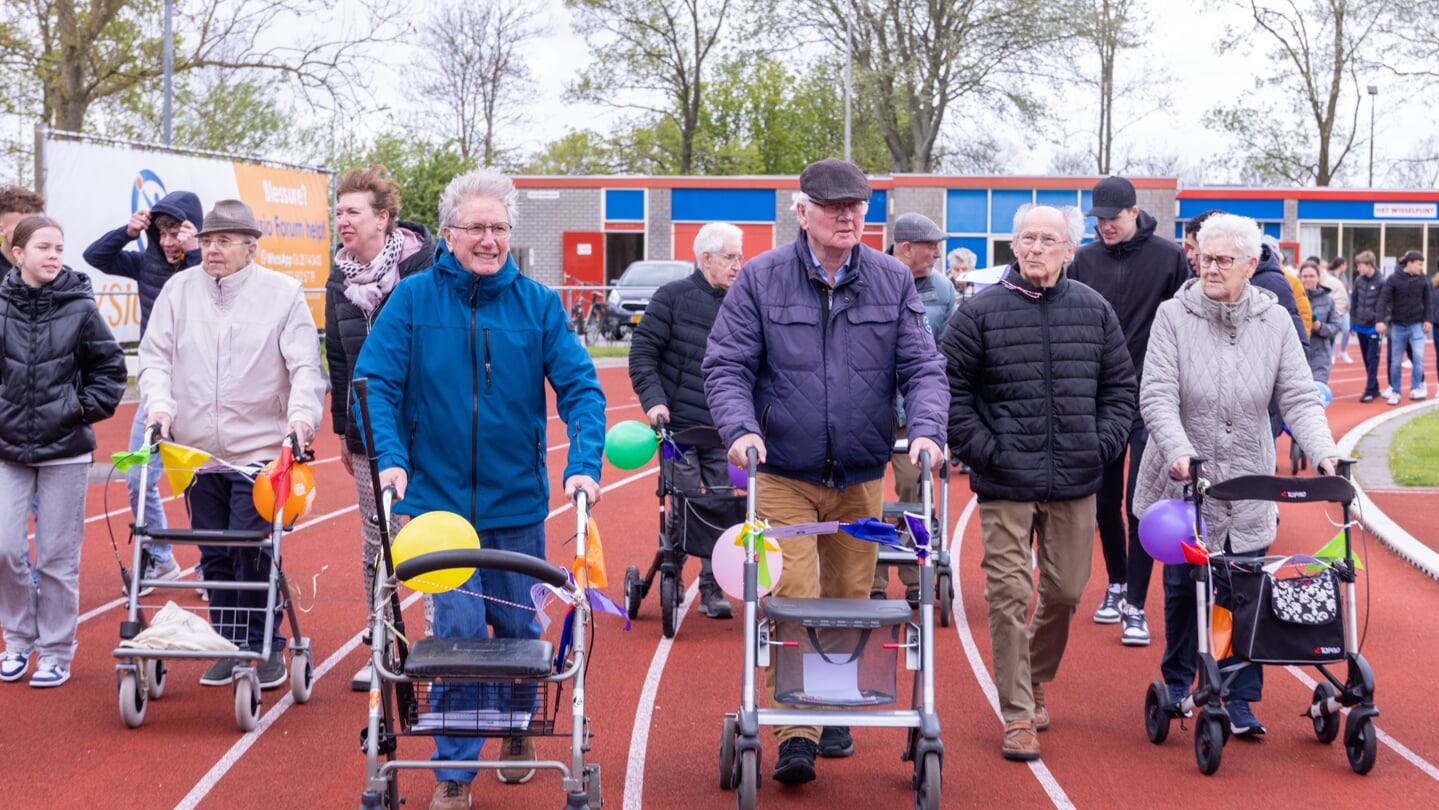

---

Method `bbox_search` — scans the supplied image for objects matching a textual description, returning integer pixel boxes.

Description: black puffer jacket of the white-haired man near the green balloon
[629,269,724,429]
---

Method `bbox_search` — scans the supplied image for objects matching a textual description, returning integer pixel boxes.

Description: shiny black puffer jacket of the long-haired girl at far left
[0,268,125,465]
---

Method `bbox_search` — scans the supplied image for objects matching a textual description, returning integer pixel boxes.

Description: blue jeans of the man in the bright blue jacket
[430,522,544,783]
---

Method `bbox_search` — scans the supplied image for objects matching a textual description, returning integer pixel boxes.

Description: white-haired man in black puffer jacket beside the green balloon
[629,222,744,619]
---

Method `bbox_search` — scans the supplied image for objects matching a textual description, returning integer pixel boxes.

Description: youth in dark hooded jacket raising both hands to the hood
[85,191,204,596]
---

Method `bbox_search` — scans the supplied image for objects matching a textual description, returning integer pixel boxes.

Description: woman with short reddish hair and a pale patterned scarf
[325,165,435,692]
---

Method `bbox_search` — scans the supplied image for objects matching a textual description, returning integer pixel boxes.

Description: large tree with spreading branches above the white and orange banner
[0,0,396,131]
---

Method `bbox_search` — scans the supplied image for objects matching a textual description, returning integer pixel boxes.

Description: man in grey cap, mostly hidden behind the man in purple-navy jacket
[869,213,957,607]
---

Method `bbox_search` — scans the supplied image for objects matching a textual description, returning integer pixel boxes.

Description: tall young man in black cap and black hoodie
[1069,177,1190,646]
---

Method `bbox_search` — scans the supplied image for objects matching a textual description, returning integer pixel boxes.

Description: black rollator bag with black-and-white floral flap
[1229,568,1344,663]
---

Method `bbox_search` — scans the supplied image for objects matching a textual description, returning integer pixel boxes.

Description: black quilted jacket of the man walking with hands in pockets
[941,266,1138,501]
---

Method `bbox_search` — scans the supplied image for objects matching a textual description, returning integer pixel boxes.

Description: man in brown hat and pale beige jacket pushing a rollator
[137,200,325,689]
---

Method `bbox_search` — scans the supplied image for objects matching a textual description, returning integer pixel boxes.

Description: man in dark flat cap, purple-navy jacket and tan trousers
[702,158,950,784]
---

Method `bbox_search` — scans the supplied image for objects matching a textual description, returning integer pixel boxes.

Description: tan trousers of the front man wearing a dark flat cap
[754,473,884,744]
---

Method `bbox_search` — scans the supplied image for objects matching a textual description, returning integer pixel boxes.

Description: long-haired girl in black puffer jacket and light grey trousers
[0,216,125,688]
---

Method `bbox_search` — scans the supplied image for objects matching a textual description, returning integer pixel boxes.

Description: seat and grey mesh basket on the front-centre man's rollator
[764,597,911,706]
